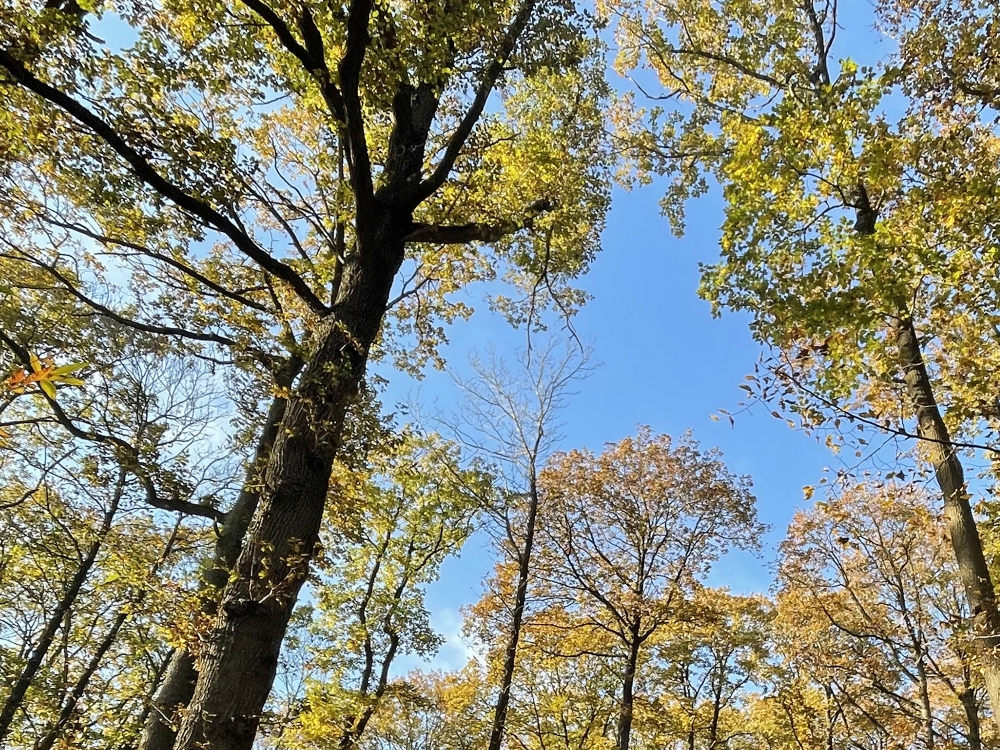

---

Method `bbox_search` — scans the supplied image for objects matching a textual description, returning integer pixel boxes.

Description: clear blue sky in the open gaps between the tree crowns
[387,179,837,671]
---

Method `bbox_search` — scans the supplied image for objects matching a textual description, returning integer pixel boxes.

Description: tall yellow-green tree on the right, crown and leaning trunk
[606,0,1000,724]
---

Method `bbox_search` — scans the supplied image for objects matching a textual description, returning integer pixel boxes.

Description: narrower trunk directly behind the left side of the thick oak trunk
[139,357,302,750]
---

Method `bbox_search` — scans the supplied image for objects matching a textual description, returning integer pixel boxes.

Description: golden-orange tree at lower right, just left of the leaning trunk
[778,484,987,748]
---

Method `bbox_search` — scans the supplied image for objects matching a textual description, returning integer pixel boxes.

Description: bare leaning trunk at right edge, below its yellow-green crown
[893,314,1000,729]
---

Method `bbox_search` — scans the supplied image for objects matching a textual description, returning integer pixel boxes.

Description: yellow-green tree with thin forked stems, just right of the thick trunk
[283,431,490,750]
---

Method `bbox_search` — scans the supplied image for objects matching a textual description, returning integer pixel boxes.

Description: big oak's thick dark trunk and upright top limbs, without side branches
[168,0,535,736]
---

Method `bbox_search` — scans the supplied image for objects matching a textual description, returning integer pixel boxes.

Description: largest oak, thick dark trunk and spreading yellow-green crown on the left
[0,0,609,750]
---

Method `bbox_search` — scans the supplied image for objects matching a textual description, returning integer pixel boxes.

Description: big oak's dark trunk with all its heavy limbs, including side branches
[0,0,544,750]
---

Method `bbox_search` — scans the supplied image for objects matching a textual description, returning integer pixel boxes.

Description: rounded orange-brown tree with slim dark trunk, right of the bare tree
[534,428,763,750]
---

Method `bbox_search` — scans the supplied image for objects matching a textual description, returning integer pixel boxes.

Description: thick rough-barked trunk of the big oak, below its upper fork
[174,235,408,750]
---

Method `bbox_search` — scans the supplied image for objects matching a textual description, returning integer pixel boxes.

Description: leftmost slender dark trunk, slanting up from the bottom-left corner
[0,469,127,747]
